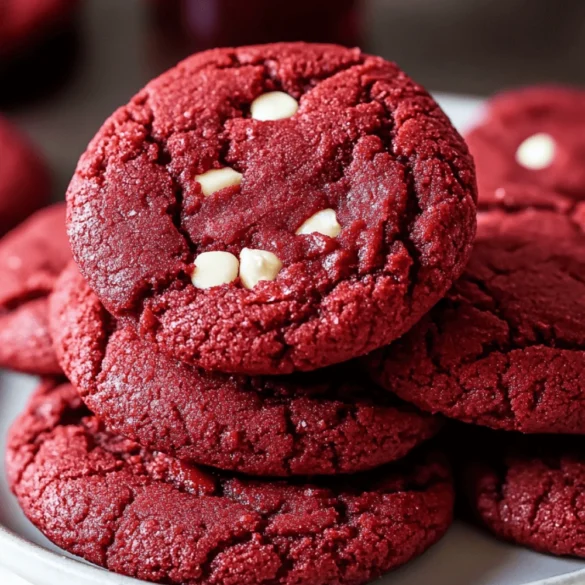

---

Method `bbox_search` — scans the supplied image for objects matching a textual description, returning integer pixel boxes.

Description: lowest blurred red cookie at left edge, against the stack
[0,203,71,374]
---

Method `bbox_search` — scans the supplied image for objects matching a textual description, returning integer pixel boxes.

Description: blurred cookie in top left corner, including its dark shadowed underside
[0,0,80,107]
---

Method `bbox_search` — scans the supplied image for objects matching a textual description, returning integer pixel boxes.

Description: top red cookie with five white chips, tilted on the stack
[68,43,476,375]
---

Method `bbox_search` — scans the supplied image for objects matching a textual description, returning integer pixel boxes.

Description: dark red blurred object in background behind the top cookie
[150,0,361,65]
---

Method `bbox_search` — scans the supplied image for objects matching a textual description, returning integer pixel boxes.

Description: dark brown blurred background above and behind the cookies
[0,0,585,198]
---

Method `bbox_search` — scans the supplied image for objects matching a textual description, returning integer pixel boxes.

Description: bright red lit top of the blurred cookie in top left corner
[0,0,78,58]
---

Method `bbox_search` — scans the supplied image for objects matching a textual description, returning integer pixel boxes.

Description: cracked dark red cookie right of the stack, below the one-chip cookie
[366,203,585,434]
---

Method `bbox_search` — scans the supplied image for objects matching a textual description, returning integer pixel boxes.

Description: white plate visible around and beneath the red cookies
[0,96,585,585]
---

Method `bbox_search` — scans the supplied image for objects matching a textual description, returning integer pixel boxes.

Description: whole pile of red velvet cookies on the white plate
[5,43,585,585]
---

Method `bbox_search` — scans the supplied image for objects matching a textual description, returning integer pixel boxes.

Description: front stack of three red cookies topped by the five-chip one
[6,44,476,585]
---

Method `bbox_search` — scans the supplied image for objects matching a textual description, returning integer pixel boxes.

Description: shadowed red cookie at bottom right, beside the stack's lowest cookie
[463,434,585,557]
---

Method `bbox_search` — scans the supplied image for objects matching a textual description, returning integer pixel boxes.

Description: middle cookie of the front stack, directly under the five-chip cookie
[50,265,441,476]
